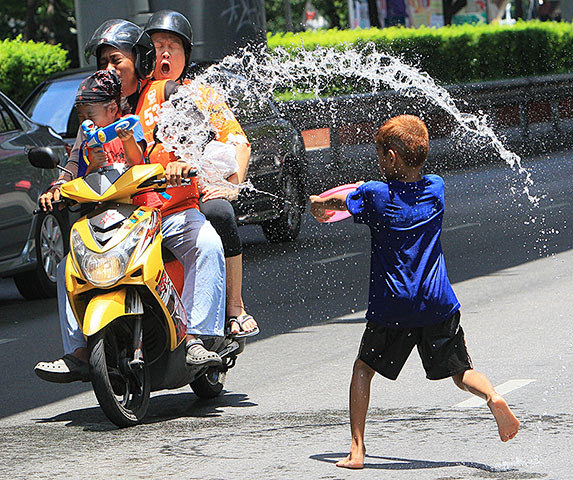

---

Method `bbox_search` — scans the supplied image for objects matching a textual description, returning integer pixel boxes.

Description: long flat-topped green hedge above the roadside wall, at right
[268,21,573,93]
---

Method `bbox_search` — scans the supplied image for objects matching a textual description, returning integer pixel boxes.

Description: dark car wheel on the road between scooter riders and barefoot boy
[261,170,304,243]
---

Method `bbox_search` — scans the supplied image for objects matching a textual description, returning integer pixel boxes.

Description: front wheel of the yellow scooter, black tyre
[88,321,151,427]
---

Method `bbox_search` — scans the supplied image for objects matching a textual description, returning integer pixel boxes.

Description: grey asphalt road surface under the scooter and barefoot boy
[0,149,573,480]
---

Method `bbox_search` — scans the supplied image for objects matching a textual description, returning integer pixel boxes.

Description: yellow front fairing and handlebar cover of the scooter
[62,165,187,350]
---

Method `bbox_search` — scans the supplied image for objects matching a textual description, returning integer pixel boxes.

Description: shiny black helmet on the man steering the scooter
[85,18,155,79]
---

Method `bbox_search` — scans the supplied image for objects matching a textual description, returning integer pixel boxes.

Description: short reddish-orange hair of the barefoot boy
[374,115,430,167]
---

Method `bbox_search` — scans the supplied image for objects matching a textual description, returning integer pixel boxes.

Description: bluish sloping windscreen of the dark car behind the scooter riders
[25,78,83,137]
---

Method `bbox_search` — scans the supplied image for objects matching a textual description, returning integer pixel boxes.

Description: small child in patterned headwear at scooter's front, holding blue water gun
[75,70,147,176]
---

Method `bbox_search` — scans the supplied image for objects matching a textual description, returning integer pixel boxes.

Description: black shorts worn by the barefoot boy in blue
[358,310,473,380]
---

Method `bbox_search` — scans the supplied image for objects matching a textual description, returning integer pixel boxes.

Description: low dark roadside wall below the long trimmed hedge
[282,74,573,191]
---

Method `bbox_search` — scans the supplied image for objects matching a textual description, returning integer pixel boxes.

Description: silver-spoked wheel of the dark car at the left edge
[14,211,68,300]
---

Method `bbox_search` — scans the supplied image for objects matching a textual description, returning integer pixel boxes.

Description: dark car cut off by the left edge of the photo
[0,93,67,299]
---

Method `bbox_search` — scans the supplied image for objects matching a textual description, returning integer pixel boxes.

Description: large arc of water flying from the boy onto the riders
[159,44,540,206]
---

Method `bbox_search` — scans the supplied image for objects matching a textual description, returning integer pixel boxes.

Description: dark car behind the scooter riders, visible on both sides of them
[22,69,306,242]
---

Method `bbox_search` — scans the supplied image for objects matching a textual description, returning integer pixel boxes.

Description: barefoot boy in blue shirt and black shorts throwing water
[310,115,519,468]
